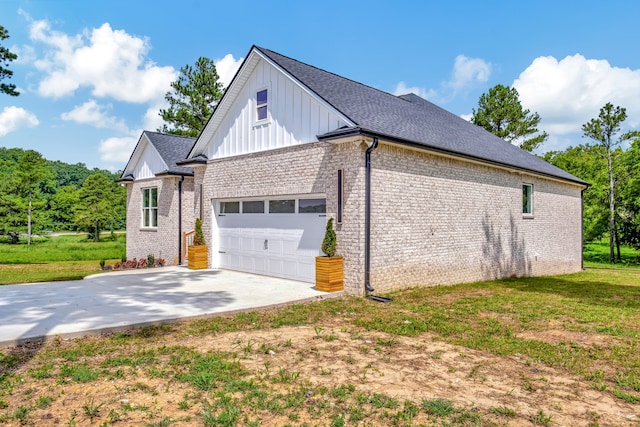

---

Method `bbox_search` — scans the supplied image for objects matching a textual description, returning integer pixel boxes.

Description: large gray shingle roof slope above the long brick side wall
[255,46,586,184]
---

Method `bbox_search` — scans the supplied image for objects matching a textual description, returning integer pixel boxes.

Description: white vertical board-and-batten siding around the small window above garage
[205,59,346,159]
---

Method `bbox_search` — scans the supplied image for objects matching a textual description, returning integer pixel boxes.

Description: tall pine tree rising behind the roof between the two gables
[158,57,224,137]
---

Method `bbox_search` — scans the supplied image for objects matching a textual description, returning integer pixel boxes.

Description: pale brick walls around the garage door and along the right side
[196,140,582,294]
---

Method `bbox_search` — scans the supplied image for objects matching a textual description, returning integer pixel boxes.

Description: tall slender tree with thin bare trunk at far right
[582,102,637,264]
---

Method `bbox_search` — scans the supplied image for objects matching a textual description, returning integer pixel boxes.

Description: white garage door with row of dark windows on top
[214,197,326,283]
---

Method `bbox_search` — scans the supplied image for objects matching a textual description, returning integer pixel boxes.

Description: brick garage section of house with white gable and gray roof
[127,46,586,294]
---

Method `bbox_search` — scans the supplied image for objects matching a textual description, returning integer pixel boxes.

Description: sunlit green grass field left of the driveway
[0,234,126,285]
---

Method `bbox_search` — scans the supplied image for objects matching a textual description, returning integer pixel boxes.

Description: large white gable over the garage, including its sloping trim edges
[189,47,354,159]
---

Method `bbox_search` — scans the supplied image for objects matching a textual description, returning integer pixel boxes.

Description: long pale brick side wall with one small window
[371,144,582,290]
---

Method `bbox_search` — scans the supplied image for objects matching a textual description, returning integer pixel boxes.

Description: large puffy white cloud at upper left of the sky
[30,20,177,103]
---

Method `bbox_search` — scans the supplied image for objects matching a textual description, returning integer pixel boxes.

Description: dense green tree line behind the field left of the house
[0,147,126,240]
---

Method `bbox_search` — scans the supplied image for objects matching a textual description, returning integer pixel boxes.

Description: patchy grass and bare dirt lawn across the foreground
[0,268,640,426]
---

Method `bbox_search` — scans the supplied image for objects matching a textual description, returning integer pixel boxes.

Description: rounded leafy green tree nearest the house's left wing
[75,173,124,242]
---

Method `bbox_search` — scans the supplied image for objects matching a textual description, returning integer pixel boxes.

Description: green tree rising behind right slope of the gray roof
[471,85,549,151]
